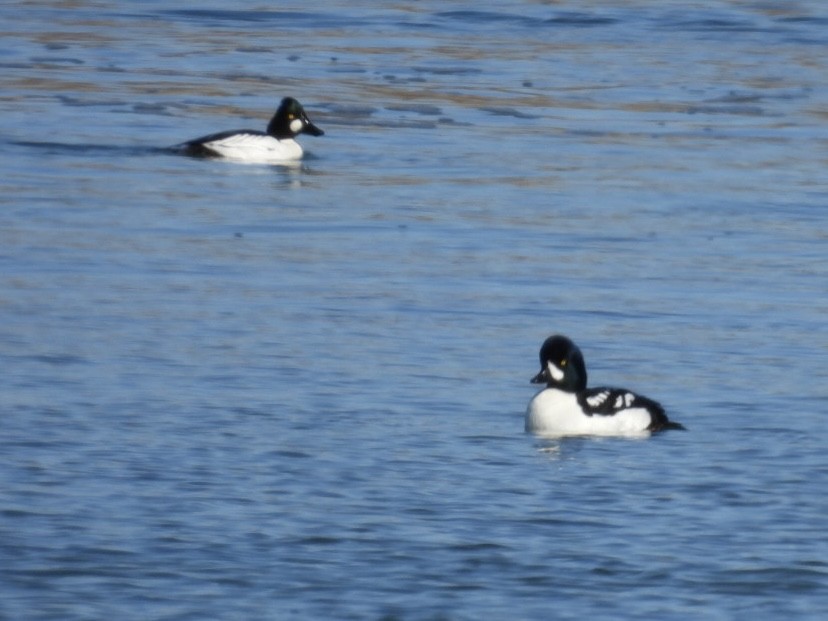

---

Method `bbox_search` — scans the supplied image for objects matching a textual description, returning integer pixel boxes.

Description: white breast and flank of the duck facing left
[526,388,650,436]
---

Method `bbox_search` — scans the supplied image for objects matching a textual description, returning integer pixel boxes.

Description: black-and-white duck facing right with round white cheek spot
[173,97,325,164]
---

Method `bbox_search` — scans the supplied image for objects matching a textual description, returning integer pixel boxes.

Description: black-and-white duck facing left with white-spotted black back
[525,334,685,437]
